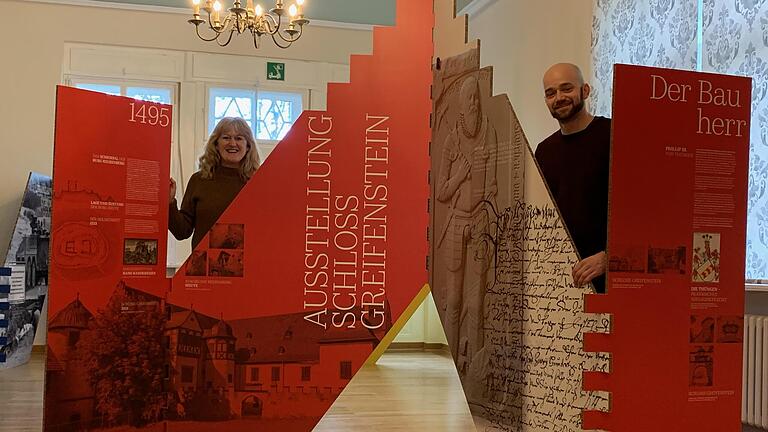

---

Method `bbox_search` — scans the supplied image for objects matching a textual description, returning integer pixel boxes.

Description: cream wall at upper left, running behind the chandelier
[0,1,372,343]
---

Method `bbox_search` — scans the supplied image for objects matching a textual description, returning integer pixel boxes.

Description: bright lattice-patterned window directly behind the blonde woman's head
[208,87,304,141]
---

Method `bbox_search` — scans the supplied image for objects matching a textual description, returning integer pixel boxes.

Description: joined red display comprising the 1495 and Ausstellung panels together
[45,1,433,432]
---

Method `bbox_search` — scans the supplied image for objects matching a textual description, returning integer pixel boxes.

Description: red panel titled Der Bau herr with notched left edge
[584,65,751,432]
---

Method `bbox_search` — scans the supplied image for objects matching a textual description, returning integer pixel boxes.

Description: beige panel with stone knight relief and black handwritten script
[431,0,609,431]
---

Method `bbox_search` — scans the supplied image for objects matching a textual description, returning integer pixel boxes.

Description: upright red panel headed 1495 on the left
[45,87,172,431]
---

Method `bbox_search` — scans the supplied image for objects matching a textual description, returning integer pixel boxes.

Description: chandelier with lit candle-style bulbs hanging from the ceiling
[188,0,309,48]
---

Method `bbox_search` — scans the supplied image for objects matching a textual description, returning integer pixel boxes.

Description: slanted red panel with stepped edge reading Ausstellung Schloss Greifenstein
[168,1,433,431]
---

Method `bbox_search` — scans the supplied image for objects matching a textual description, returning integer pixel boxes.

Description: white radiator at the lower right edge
[741,315,768,430]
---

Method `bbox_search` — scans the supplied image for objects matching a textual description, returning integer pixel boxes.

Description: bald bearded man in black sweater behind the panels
[536,63,611,292]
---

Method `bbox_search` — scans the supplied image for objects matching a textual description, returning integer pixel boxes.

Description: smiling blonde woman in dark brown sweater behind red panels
[168,117,260,248]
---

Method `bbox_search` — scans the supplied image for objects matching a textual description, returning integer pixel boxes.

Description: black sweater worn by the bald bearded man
[536,117,611,292]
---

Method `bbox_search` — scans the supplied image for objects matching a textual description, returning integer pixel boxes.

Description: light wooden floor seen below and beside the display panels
[0,350,475,432]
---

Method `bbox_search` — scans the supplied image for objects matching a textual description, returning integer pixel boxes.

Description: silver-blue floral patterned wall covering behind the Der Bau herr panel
[590,0,768,279]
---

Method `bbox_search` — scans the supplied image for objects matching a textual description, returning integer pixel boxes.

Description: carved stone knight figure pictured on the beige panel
[436,72,497,375]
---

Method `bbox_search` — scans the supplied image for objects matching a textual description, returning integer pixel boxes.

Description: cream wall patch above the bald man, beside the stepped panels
[467,0,593,148]
